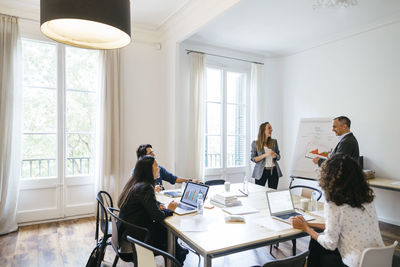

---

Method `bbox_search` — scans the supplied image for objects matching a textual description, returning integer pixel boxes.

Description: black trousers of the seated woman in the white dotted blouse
[307,238,346,267]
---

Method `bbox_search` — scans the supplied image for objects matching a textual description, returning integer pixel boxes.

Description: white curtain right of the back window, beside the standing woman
[247,63,265,177]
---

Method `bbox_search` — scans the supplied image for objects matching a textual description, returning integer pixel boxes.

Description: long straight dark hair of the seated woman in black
[118,156,155,209]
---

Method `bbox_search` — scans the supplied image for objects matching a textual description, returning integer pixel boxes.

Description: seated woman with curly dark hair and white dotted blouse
[291,154,384,267]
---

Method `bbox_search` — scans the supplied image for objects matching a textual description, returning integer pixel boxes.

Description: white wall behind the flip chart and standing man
[277,23,400,225]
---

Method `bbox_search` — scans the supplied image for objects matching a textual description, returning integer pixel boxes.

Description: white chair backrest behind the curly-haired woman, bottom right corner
[360,241,398,267]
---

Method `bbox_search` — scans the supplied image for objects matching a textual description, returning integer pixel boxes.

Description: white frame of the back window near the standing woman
[204,62,250,180]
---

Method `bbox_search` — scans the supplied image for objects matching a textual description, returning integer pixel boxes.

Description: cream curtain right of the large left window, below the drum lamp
[97,50,123,202]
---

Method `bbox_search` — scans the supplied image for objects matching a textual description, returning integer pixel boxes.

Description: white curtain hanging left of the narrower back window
[189,52,206,180]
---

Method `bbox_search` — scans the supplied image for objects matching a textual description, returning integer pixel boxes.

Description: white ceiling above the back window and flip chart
[189,0,400,55]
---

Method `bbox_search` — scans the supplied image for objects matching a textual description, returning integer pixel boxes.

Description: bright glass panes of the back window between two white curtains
[205,67,248,169]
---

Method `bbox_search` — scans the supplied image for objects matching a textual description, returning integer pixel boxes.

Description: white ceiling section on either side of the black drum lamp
[0,0,190,30]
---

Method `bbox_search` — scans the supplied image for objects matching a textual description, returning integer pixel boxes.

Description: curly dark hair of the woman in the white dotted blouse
[319,153,375,209]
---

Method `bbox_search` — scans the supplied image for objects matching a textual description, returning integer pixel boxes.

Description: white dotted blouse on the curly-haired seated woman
[317,202,384,267]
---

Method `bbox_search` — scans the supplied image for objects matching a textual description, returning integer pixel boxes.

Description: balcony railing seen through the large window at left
[21,157,92,178]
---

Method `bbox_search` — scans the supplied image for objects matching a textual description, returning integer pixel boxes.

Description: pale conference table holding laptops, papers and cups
[157,183,323,267]
